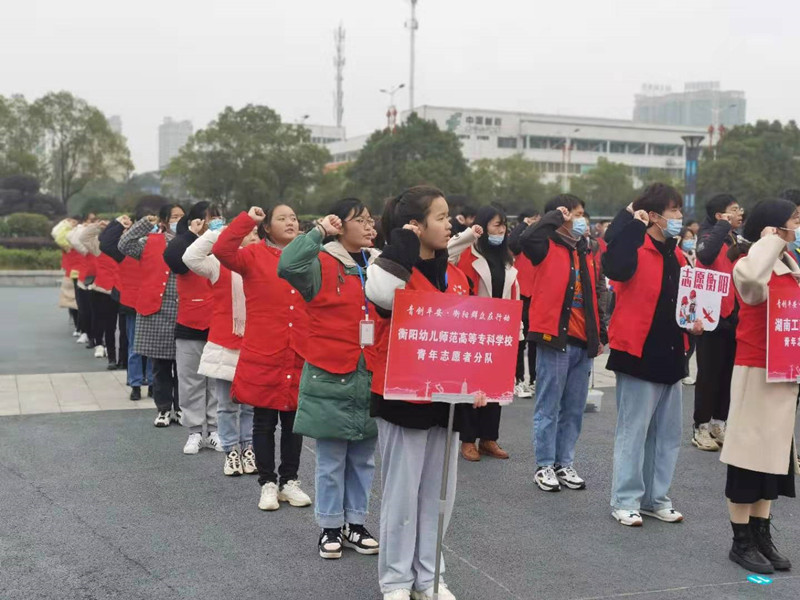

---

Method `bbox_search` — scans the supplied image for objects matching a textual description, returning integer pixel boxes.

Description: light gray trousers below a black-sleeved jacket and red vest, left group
[175,339,217,433]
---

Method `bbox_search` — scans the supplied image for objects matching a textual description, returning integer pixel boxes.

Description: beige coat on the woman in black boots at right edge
[720,235,800,475]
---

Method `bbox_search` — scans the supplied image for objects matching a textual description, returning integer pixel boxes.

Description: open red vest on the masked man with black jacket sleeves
[528,240,600,339]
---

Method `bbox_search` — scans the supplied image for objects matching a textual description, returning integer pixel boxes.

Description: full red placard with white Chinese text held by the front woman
[384,290,522,404]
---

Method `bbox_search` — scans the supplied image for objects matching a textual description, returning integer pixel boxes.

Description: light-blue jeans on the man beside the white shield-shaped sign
[611,373,683,510]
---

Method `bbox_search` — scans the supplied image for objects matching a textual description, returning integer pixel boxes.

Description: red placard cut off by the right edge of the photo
[767,287,800,383]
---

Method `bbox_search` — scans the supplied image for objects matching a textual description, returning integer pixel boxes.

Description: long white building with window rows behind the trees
[327,106,705,181]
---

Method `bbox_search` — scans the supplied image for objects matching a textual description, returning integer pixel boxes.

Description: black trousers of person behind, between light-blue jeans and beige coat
[694,322,736,427]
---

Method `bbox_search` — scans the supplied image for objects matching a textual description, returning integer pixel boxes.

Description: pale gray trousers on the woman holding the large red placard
[377,419,459,594]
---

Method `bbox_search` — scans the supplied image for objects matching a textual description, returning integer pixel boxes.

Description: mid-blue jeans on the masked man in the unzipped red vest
[533,344,592,467]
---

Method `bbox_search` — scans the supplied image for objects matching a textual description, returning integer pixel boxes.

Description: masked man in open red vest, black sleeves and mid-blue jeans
[520,194,607,492]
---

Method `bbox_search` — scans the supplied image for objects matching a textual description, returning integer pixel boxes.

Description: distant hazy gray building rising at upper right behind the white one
[633,81,747,128]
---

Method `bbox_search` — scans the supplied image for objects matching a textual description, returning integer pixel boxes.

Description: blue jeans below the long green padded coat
[314,436,378,529]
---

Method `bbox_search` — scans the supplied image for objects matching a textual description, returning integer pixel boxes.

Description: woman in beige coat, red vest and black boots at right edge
[720,200,800,573]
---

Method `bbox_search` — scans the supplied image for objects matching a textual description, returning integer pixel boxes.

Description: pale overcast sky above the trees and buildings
[0,0,800,172]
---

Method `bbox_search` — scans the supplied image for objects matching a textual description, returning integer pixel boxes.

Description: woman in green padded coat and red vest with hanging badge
[278,198,379,559]
